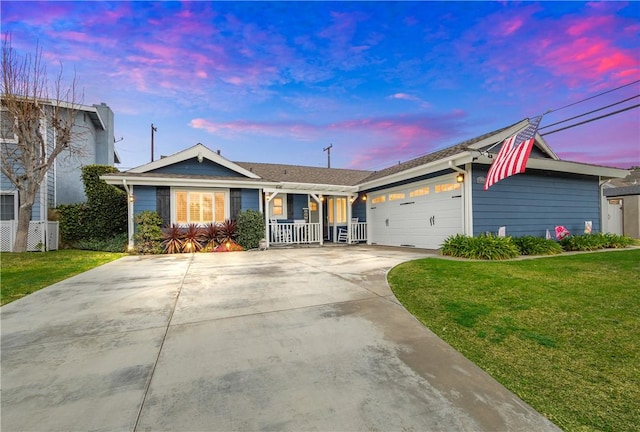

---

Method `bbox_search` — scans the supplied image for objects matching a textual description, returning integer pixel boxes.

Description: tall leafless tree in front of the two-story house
[0,36,82,252]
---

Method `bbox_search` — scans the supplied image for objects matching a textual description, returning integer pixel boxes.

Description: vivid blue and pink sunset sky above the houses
[0,0,640,170]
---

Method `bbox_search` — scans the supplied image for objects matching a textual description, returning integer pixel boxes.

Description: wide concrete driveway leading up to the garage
[1,246,557,432]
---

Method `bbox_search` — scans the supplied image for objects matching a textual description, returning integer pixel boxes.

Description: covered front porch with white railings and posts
[263,185,367,247]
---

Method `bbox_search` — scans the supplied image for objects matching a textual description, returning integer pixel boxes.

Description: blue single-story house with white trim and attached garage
[102,119,628,249]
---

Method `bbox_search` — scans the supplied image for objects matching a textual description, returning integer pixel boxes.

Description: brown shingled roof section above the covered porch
[236,162,371,186]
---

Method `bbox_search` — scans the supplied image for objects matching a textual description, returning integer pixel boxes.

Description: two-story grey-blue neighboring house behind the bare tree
[0,103,120,251]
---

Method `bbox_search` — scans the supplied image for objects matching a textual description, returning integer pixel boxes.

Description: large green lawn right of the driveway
[389,250,640,432]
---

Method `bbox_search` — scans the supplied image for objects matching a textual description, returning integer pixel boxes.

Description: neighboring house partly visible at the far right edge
[603,168,640,239]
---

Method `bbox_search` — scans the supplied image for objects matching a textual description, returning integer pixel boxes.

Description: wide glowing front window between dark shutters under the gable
[175,190,228,225]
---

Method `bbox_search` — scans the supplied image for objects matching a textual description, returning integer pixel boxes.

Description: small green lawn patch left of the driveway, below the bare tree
[0,249,125,305]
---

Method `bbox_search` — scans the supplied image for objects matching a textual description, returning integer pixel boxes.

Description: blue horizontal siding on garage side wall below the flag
[471,166,600,237]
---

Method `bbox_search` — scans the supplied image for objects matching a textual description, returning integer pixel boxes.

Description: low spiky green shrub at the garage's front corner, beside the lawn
[441,234,519,260]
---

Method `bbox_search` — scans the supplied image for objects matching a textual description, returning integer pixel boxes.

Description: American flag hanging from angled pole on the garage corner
[484,116,542,190]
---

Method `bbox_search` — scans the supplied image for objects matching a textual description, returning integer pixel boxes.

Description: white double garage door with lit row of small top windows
[367,176,463,249]
